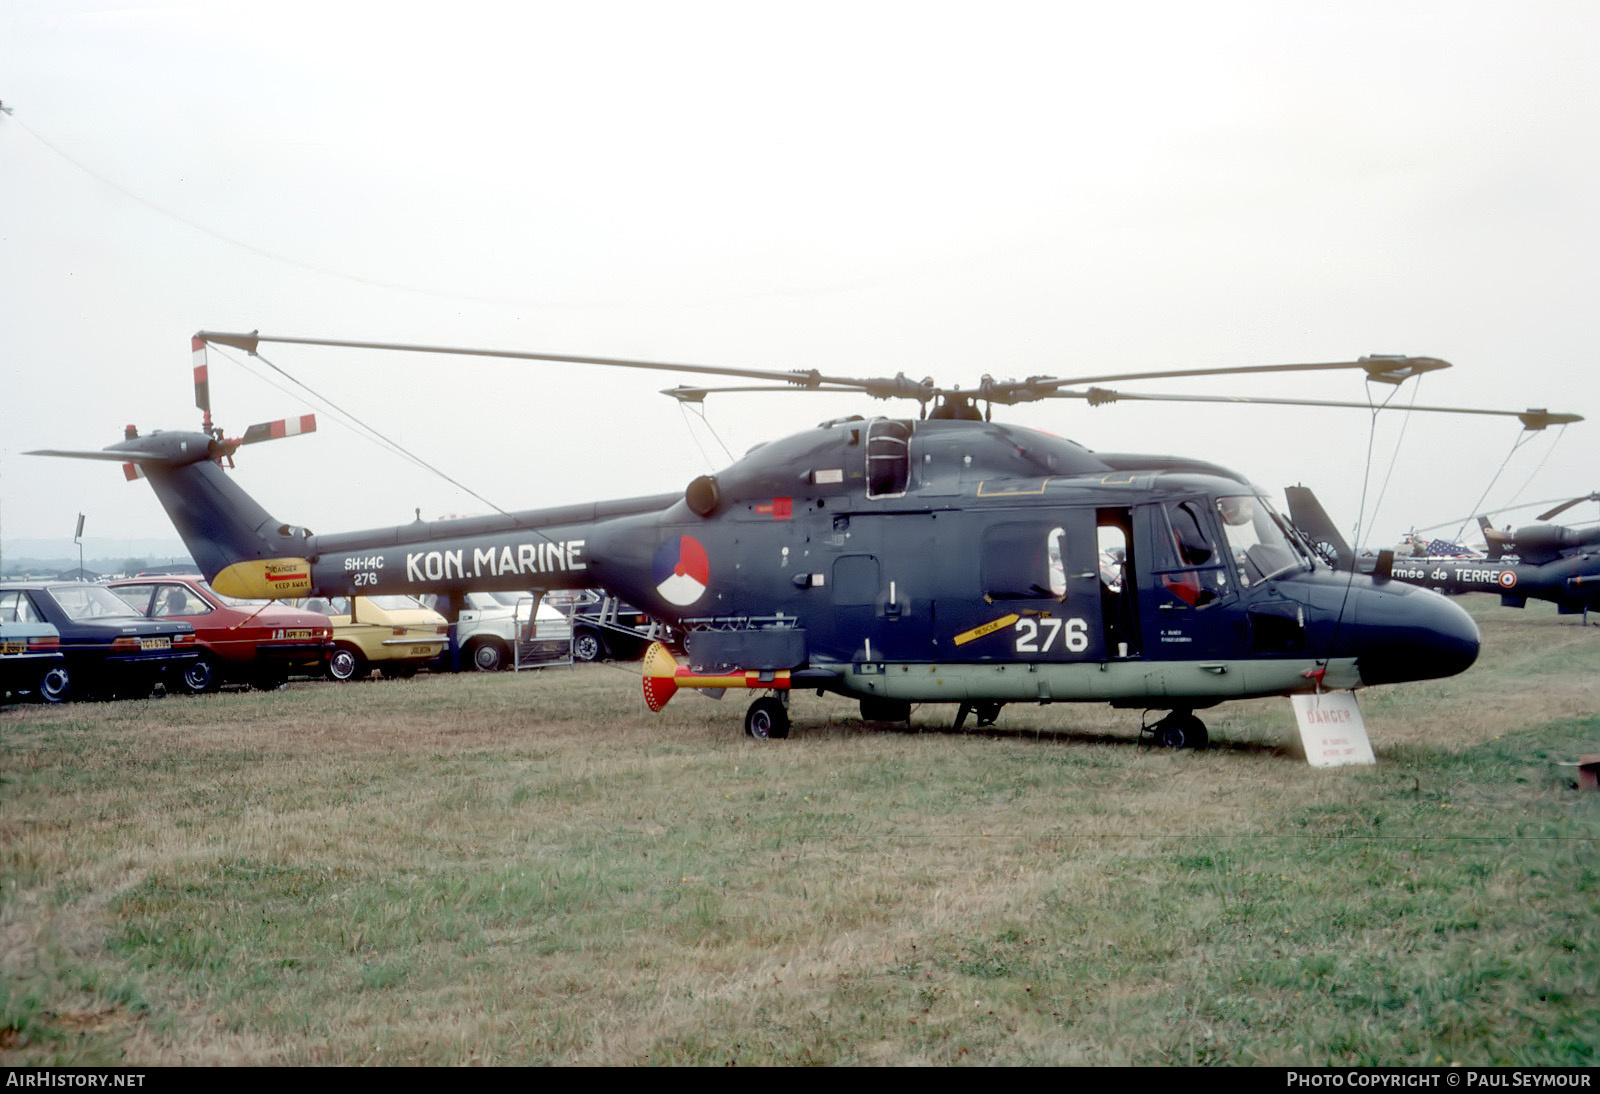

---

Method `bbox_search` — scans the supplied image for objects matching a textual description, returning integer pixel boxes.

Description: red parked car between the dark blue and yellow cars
[106,574,333,696]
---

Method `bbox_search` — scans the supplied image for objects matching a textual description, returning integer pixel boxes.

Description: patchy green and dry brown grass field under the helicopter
[0,598,1600,1065]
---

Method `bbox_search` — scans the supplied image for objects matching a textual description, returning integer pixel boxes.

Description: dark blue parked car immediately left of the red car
[0,581,198,699]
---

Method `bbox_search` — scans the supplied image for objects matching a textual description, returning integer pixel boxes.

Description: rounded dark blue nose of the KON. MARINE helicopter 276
[1355,582,1478,685]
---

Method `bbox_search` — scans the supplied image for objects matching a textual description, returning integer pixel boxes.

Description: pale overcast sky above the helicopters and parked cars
[0,0,1600,544]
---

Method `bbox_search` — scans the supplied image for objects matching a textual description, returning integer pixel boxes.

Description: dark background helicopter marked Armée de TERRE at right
[1288,486,1600,624]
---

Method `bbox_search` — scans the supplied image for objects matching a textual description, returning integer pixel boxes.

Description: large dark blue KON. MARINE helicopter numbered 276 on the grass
[40,331,1570,749]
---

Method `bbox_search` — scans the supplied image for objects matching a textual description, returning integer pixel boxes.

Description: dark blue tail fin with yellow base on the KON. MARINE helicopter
[30,432,310,597]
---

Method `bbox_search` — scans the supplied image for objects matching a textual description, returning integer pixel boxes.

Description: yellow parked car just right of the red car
[294,595,450,680]
